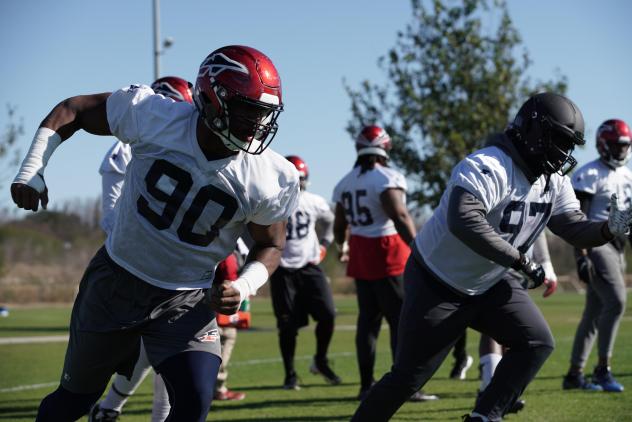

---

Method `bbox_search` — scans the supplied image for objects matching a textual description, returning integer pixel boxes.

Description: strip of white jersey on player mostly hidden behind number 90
[99,141,132,234]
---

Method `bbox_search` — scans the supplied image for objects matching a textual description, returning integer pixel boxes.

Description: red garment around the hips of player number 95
[347,234,410,280]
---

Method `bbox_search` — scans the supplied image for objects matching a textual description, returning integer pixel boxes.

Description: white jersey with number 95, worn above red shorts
[333,164,407,237]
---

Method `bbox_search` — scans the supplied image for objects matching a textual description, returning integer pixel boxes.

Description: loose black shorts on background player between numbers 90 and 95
[270,264,336,329]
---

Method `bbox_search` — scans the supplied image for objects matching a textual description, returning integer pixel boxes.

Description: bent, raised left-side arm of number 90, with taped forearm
[11,93,111,211]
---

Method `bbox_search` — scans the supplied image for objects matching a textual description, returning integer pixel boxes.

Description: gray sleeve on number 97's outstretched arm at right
[547,210,612,249]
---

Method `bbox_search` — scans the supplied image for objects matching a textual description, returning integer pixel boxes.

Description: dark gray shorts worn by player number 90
[61,248,221,393]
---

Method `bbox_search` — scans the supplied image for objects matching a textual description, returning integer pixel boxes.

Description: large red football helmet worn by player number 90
[193,45,283,154]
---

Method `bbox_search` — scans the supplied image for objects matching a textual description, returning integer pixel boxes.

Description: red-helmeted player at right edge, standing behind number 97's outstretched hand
[562,119,632,392]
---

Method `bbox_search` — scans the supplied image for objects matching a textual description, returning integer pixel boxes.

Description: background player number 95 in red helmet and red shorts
[333,125,436,401]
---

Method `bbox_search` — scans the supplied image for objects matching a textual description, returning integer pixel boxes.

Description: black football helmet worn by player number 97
[507,92,586,176]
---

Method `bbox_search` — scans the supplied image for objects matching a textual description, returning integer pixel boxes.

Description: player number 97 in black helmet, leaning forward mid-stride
[352,93,632,421]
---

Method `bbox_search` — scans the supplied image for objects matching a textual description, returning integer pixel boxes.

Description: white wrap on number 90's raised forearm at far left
[13,127,61,193]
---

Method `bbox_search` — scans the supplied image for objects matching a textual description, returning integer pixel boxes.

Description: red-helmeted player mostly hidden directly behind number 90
[88,76,193,422]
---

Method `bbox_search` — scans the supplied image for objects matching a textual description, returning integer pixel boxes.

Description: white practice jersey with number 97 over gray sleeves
[415,146,579,295]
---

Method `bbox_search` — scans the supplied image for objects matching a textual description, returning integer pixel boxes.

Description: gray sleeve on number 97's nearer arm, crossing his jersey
[447,186,520,267]
